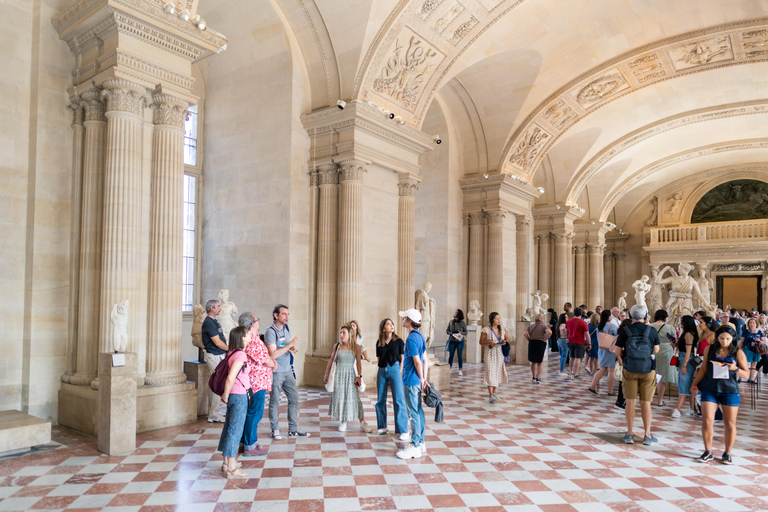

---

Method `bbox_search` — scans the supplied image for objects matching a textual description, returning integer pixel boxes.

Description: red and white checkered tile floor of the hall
[0,357,768,512]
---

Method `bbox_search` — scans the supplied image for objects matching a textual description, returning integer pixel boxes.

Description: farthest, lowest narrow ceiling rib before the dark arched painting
[599,138,768,222]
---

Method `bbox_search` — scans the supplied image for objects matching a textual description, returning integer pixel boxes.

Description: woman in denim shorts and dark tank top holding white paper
[693,326,749,464]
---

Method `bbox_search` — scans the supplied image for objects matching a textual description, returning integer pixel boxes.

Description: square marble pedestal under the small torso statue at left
[97,353,138,455]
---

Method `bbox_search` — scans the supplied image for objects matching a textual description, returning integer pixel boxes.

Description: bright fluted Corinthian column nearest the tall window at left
[144,94,189,386]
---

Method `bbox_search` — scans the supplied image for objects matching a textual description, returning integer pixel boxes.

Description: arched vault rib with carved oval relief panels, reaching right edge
[499,18,768,181]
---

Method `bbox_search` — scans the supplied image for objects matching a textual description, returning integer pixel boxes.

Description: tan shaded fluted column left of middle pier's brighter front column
[313,164,339,357]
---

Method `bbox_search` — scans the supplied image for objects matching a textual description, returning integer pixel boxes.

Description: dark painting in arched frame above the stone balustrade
[691,180,768,224]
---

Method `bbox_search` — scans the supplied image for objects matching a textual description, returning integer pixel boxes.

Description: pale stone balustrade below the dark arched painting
[650,219,768,247]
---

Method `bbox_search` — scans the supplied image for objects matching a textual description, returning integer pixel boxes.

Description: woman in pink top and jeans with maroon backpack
[219,325,251,478]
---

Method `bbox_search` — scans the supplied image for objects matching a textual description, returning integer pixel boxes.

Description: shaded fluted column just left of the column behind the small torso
[69,91,107,386]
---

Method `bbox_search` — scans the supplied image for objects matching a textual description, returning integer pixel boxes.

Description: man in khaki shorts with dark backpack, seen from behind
[614,304,659,445]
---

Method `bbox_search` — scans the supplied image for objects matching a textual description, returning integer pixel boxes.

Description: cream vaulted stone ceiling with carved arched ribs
[200,0,768,229]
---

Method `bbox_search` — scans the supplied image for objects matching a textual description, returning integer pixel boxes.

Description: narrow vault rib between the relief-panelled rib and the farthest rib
[565,99,768,206]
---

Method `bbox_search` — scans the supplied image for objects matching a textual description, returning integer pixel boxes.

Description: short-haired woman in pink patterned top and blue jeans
[238,311,277,457]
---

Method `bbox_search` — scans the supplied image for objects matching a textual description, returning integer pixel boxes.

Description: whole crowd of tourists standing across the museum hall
[202,299,768,478]
